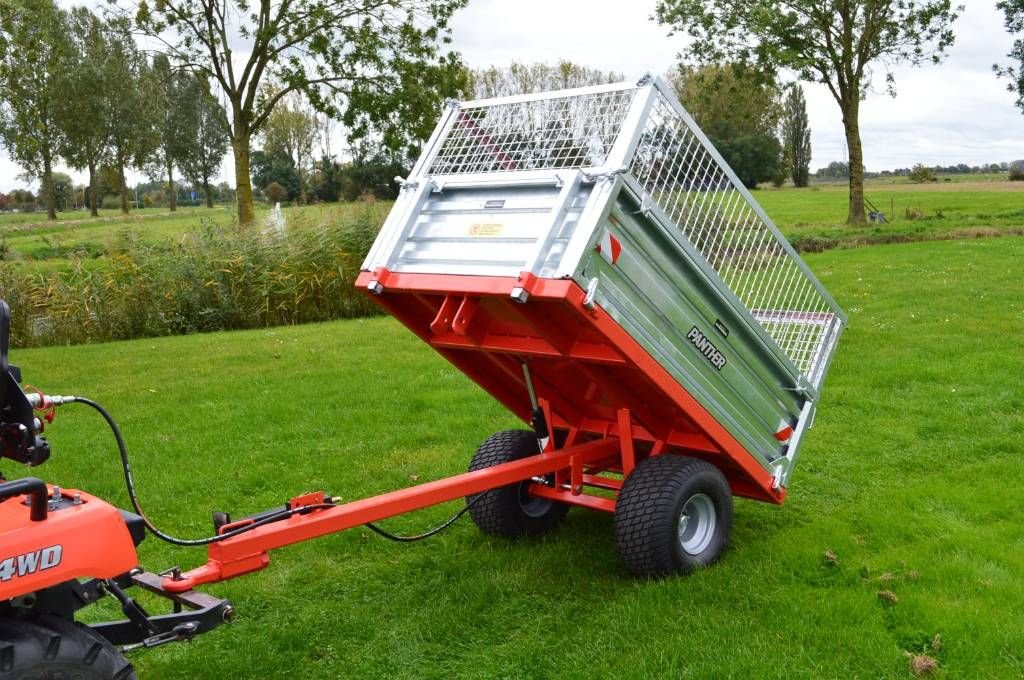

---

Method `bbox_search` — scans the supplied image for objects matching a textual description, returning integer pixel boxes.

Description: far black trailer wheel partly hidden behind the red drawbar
[466,430,569,538]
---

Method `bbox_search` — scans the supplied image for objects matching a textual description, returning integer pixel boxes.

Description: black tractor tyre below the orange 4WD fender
[0,617,137,680]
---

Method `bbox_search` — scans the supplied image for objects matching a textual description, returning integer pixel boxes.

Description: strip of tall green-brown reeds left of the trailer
[0,205,384,346]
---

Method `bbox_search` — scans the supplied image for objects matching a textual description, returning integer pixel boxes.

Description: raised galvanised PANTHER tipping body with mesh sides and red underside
[357,78,846,502]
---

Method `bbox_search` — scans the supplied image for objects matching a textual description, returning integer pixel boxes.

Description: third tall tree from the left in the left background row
[102,19,161,215]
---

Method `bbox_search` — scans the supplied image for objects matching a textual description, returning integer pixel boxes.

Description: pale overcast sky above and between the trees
[0,0,1024,190]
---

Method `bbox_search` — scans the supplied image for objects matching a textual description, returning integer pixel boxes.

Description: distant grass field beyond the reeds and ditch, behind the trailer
[0,175,1024,270]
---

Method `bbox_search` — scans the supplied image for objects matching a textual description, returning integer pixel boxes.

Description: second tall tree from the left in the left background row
[58,7,111,217]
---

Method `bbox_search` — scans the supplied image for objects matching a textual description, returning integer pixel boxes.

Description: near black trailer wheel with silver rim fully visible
[614,455,732,579]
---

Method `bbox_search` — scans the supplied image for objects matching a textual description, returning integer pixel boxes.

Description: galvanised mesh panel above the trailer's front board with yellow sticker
[428,89,636,175]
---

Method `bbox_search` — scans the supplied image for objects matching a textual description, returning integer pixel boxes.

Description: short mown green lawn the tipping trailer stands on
[4,238,1024,679]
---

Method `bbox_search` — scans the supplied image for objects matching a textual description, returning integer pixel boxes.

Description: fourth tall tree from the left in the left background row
[151,54,199,212]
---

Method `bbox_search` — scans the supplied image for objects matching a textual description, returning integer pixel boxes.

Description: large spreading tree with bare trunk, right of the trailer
[656,0,962,224]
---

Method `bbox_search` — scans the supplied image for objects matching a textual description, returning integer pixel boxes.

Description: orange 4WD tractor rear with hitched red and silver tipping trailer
[0,78,846,678]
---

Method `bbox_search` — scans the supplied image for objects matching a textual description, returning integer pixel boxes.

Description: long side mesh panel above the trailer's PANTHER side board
[630,93,839,386]
